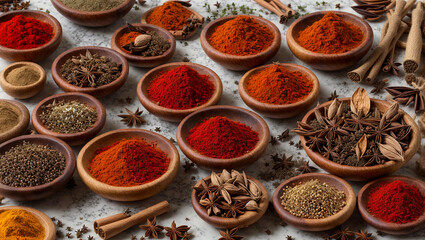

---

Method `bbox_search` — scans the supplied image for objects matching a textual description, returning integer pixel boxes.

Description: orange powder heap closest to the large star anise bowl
[246,65,313,104]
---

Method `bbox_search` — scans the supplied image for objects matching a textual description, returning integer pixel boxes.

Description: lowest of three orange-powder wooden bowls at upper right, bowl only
[239,63,320,118]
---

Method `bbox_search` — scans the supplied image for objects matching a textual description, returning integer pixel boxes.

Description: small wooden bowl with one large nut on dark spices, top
[111,23,176,68]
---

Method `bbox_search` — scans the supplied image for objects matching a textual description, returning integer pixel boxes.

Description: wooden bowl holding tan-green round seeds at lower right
[272,173,356,232]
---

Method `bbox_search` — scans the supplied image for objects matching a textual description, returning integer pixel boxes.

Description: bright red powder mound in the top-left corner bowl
[0,15,54,49]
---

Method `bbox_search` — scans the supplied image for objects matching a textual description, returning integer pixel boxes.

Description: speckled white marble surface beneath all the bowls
[0,0,425,240]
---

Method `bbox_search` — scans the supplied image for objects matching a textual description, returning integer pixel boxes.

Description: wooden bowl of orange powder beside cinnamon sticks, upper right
[286,11,373,71]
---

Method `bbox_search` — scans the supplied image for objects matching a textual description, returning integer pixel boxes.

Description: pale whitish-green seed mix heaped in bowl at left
[39,100,97,133]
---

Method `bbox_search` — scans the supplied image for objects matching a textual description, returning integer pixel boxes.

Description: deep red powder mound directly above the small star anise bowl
[187,116,259,159]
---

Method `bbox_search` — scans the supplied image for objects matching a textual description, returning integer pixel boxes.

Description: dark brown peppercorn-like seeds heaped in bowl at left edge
[0,141,66,187]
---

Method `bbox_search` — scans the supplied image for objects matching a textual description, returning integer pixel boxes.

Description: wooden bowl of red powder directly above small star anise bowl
[177,105,270,170]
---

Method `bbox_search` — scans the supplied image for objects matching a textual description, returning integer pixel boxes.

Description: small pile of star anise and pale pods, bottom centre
[193,170,262,218]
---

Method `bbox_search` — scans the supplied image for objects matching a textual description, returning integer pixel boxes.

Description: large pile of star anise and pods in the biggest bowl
[293,88,412,166]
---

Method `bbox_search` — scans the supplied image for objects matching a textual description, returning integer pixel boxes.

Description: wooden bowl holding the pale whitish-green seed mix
[31,92,106,146]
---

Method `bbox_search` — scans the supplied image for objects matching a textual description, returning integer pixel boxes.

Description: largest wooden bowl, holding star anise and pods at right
[300,98,421,181]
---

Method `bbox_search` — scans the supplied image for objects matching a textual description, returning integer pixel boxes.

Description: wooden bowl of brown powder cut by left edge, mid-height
[0,99,30,143]
